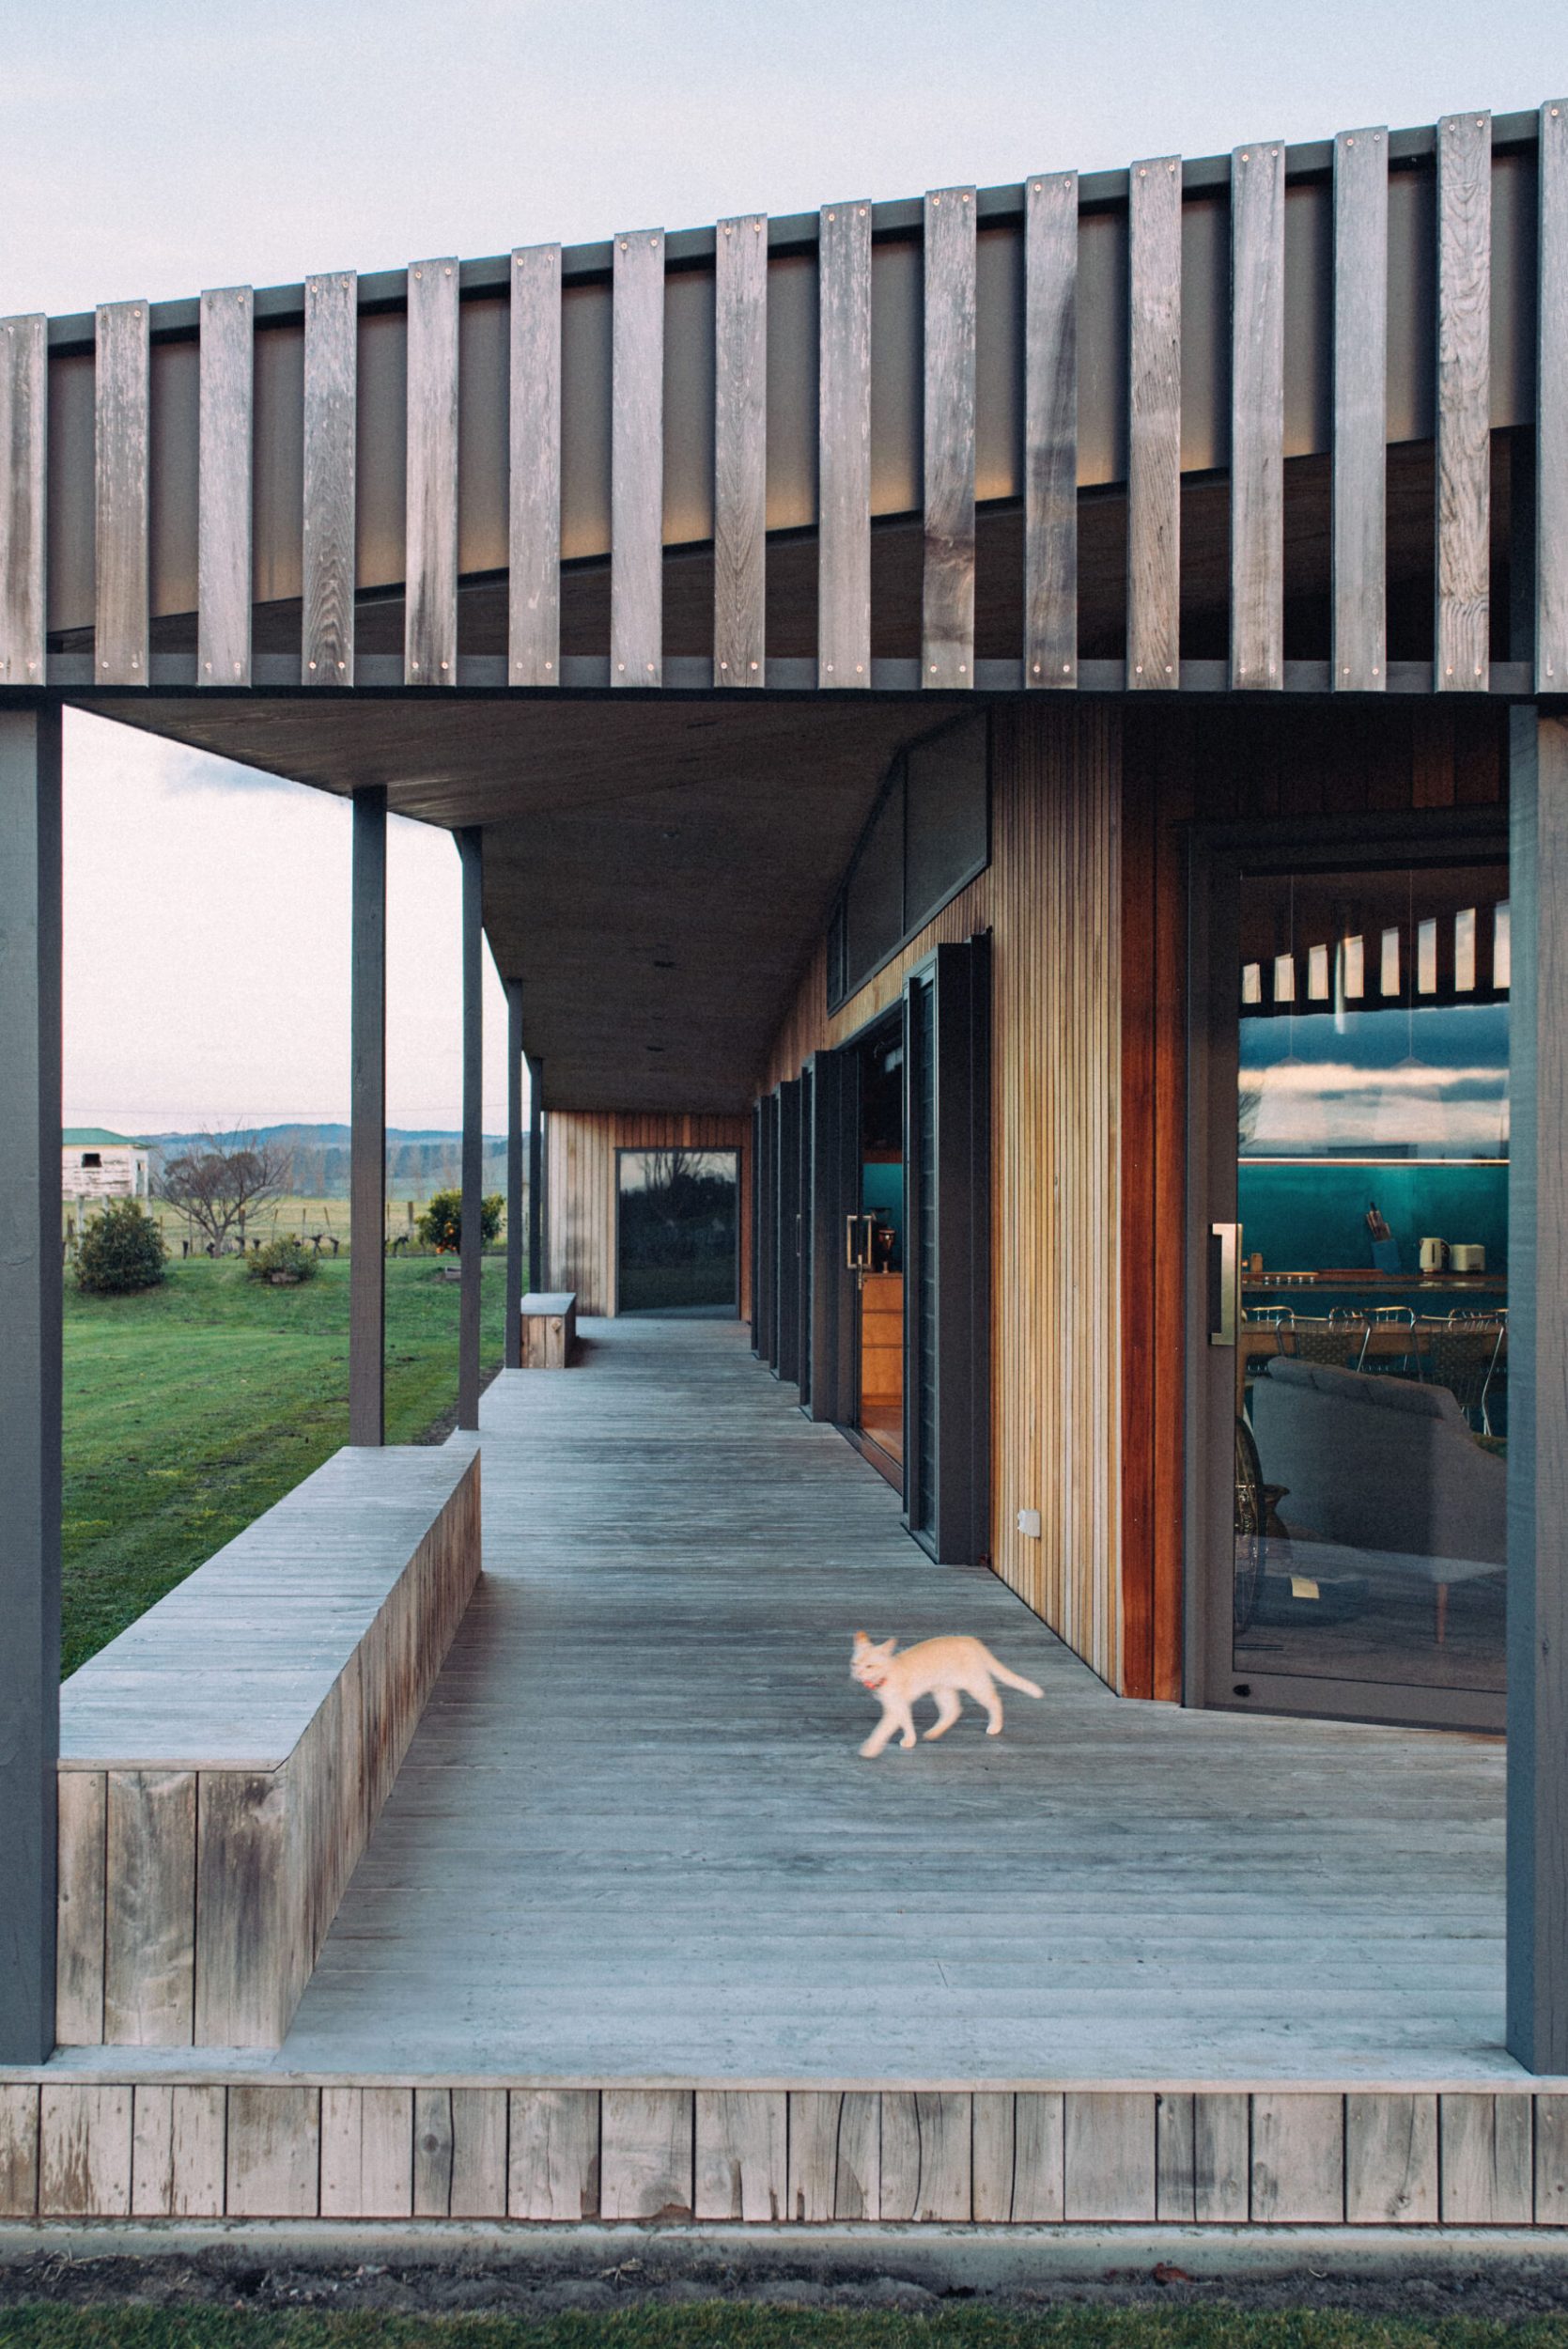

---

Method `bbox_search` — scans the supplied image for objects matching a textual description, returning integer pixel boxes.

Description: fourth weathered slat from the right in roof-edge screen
[1230,139,1284,691]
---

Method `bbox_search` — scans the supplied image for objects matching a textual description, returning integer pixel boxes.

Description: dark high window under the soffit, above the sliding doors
[829,714,990,1010]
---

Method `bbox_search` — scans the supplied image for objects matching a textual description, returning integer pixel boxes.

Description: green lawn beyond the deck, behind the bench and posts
[59,1257,505,1682]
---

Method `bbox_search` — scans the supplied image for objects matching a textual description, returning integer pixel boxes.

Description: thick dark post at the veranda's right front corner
[1507,709,1568,2072]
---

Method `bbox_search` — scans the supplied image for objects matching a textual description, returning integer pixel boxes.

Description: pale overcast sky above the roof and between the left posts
[0,0,1568,1128]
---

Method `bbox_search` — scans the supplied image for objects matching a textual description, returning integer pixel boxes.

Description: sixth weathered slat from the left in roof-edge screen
[507,244,561,686]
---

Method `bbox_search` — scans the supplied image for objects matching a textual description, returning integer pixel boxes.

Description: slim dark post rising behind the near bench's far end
[348,785,387,1445]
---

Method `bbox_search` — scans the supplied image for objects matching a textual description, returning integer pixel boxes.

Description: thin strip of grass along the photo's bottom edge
[0,2300,1568,2349]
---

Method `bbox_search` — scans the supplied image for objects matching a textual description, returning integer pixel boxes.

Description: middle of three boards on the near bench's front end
[103,1769,197,2046]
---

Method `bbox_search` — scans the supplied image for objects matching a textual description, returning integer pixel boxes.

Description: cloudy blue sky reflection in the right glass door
[1239,1003,1507,1159]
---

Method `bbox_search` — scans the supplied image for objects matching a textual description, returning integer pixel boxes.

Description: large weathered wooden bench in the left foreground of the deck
[56,1445,479,2046]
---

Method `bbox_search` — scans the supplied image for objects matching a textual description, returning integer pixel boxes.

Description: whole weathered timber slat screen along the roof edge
[12,101,1568,693]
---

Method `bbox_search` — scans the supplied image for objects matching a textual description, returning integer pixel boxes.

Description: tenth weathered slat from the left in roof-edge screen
[920,188,976,686]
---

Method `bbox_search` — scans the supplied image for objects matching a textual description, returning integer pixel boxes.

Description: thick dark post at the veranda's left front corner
[0,709,61,2062]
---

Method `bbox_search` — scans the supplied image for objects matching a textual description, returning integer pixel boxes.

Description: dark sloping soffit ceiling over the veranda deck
[91,695,951,1112]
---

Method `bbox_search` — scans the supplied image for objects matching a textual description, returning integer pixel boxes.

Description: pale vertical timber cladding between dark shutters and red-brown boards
[763,700,1125,1687]
